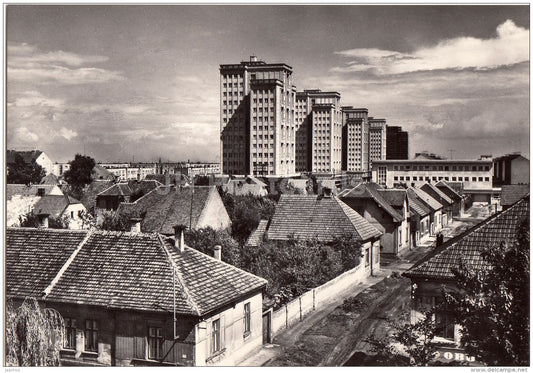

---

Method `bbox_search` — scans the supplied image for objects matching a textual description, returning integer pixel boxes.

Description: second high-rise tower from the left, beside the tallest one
[296,89,342,173]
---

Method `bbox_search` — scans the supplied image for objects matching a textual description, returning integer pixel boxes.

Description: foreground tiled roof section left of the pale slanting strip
[5,228,87,298]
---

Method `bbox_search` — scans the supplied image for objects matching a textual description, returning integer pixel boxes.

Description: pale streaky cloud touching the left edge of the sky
[7,43,124,85]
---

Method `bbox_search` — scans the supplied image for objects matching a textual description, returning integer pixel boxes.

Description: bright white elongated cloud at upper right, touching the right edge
[331,20,529,75]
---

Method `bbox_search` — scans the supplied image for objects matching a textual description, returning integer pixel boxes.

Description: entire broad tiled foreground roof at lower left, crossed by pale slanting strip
[6,228,267,316]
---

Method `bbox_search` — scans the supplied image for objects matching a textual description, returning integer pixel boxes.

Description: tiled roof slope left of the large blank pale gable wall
[117,186,214,235]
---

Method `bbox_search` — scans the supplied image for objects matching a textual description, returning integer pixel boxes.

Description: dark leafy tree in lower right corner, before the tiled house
[446,219,529,366]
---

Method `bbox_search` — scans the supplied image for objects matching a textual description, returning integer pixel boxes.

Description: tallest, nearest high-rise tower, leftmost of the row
[220,56,296,176]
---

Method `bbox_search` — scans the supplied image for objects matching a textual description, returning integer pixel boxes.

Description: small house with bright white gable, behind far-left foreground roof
[33,195,87,229]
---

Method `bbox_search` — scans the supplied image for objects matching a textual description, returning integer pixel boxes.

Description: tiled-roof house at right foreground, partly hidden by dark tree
[403,195,530,364]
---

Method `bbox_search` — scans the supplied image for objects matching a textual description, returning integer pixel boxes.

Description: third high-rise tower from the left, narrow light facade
[342,106,370,172]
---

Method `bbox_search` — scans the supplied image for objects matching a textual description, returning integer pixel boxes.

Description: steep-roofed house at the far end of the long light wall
[338,183,410,255]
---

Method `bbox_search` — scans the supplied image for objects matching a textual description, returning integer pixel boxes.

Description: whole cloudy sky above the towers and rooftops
[6,5,529,162]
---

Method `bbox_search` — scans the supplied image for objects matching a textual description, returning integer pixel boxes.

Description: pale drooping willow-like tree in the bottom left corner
[6,298,65,366]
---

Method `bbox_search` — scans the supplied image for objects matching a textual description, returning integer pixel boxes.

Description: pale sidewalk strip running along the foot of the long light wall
[235,268,393,367]
